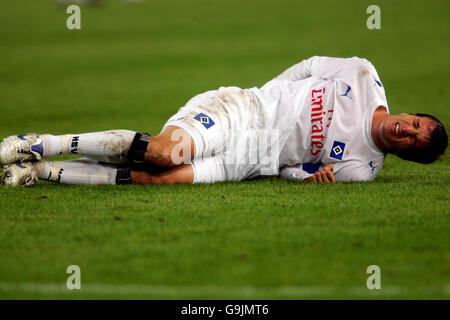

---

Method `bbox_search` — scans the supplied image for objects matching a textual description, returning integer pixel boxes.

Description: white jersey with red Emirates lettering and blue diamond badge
[250,57,388,181]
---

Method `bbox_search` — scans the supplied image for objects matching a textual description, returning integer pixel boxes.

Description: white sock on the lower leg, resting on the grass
[33,158,117,185]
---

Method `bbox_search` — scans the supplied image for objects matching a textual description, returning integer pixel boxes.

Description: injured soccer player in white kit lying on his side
[0,57,448,186]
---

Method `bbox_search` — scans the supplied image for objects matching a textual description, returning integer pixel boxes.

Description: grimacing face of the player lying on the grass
[380,113,435,154]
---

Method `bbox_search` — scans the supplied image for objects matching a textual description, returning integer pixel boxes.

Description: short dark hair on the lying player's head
[397,113,448,164]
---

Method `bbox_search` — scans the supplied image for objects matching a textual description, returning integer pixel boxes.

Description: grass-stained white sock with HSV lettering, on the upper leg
[41,130,136,162]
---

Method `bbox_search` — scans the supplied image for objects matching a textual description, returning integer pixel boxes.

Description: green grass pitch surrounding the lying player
[0,0,450,299]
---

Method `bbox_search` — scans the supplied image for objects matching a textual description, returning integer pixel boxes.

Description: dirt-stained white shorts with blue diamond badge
[165,87,279,183]
